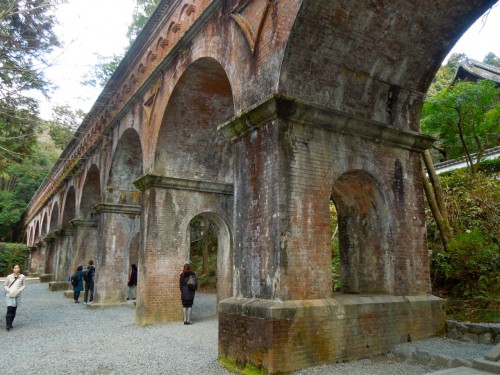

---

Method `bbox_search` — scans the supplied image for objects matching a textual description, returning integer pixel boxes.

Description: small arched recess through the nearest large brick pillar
[332,170,394,294]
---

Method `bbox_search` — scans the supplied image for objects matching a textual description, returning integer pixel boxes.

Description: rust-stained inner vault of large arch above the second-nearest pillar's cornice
[153,58,234,182]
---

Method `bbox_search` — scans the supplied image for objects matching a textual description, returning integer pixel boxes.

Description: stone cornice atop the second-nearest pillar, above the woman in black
[134,174,233,195]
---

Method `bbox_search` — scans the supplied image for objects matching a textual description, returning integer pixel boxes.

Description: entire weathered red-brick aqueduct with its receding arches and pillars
[26,0,496,373]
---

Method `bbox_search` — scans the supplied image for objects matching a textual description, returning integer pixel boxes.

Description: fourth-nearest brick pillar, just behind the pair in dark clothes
[71,219,98,269]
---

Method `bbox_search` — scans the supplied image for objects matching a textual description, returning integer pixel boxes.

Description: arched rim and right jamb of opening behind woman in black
[184,212,233,301]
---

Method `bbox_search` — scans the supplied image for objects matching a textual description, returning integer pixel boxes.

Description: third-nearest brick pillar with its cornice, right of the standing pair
[94,203,141,304]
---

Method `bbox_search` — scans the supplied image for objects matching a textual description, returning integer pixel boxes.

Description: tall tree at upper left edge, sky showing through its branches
[0,0,59,167]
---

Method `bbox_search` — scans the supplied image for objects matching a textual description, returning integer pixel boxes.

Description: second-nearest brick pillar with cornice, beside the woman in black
[134,175,233,325]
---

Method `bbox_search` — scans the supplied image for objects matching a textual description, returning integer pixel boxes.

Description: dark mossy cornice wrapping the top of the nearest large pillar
[217,94,434,152]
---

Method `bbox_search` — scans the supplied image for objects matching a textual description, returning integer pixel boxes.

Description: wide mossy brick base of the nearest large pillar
[219,294,446,374]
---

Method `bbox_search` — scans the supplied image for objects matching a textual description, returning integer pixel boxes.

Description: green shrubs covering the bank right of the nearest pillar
[427,170,500,321]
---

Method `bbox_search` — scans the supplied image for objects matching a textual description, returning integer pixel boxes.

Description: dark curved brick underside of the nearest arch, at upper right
[279,0,496,131]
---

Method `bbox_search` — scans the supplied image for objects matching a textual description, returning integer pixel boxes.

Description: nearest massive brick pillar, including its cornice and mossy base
[219,96,445,374]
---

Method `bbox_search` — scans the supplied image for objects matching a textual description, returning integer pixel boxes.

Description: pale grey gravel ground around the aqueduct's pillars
[0,283,492,375]
